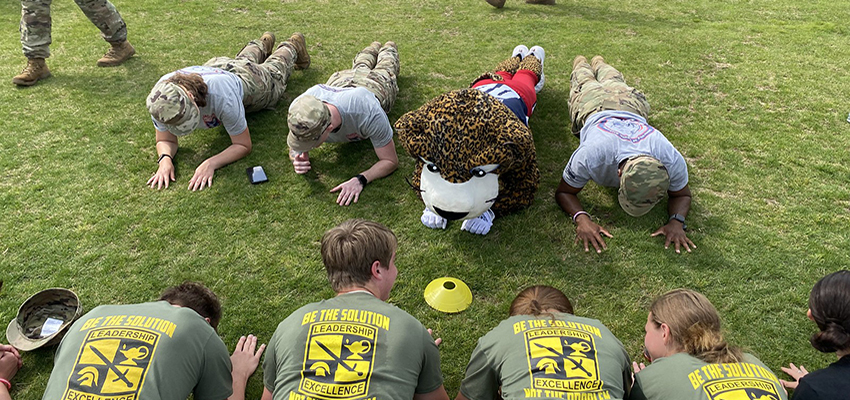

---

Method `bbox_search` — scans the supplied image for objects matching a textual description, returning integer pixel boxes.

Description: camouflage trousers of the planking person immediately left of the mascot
[326,42,400,113]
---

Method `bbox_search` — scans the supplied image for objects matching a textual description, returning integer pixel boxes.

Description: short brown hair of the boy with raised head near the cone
[322,219,398,292]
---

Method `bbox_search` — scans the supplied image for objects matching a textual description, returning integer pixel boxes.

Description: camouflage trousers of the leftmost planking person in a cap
[204,39,297,112]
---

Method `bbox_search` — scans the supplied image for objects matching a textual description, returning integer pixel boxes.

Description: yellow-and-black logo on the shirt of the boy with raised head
[298,322,378,399]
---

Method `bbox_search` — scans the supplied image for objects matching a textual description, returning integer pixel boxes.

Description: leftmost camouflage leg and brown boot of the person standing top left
[12,0,52,86]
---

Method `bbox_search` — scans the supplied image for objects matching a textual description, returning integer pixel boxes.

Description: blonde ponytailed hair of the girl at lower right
[649,289,743,363]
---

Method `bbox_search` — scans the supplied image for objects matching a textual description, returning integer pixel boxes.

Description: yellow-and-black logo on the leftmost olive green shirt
[62,327,160,400]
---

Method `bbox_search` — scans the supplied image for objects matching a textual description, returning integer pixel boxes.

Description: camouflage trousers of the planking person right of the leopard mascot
[570,56,649,137]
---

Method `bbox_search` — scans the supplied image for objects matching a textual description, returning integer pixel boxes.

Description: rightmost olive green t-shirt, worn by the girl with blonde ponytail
[632,353,788,400]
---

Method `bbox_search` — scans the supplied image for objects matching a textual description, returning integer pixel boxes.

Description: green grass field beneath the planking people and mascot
[0,0,850,400]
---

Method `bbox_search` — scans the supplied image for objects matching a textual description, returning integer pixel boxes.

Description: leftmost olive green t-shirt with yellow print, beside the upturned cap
[43,301,233,400]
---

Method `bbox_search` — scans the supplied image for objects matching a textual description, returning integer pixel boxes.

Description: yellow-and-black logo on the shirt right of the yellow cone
[525,327,602,392]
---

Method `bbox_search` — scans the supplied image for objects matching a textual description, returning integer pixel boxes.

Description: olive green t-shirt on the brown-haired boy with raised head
[263,292,443,400]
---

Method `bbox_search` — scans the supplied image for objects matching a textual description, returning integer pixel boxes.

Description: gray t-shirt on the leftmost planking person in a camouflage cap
[151,66,248,136]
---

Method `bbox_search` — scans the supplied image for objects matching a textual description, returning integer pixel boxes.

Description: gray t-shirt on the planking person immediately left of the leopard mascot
[293,85,393,149]
